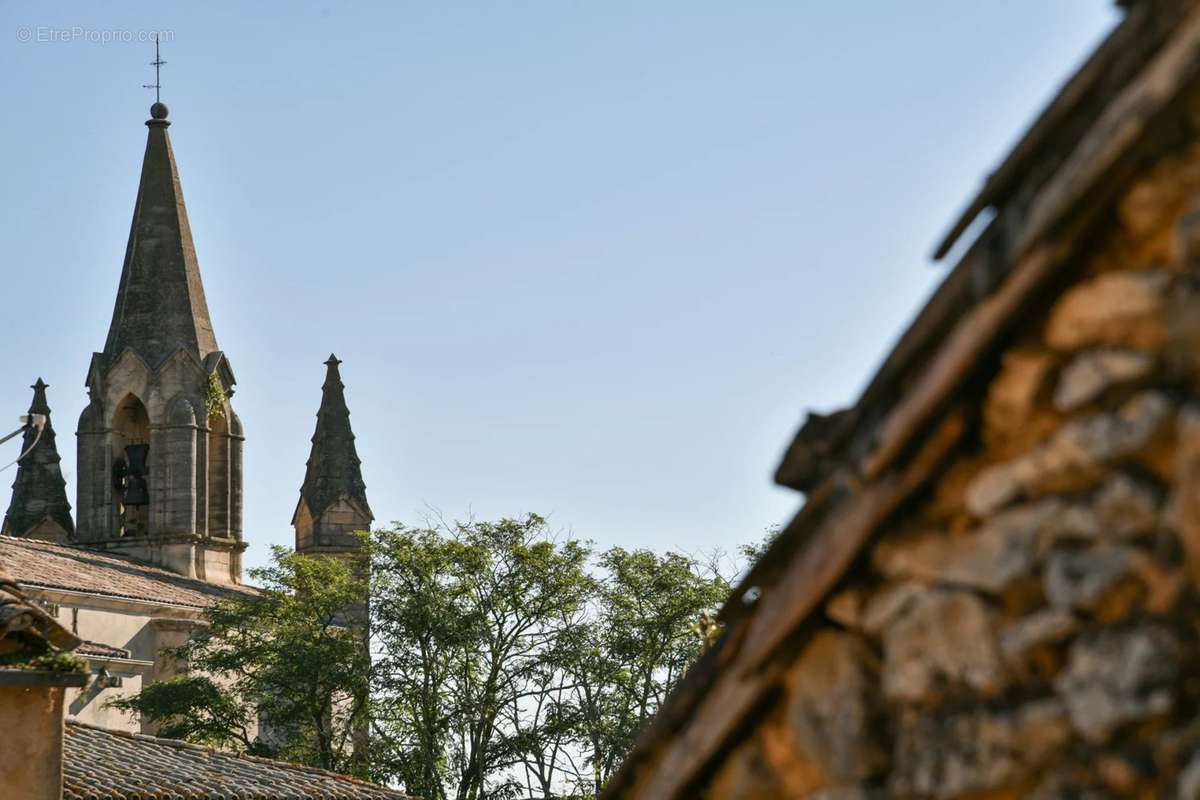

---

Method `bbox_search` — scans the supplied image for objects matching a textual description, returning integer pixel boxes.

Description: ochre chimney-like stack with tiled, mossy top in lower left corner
[0,576,88,800]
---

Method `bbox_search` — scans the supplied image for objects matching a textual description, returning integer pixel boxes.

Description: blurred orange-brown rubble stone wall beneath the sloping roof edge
[707,145,1200,800]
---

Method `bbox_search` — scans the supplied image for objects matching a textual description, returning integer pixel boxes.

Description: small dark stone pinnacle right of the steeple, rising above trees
[292,354,374,553]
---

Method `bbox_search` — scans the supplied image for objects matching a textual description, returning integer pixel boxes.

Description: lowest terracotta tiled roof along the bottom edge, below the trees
[62,720,408,800]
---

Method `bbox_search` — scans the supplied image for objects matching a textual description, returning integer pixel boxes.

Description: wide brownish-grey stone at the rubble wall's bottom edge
[889,699,1070,798]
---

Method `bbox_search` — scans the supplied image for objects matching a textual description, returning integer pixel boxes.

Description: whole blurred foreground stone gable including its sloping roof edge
[605,0,1200,800]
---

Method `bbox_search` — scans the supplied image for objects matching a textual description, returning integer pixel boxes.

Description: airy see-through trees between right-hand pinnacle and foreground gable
[372,515,728,800]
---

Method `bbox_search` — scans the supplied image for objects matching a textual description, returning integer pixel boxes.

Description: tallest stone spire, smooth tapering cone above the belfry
[103,103,217,368]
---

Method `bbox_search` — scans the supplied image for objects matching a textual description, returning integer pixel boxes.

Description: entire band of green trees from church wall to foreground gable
[115,515,730,800]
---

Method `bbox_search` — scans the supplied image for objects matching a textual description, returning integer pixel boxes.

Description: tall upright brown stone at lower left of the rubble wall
[784,631,887,784]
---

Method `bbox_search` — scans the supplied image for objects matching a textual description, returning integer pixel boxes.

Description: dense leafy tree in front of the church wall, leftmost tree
[112,548,371,775]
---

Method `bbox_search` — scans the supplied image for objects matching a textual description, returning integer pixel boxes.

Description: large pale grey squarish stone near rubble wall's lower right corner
[1055,625,1180,744]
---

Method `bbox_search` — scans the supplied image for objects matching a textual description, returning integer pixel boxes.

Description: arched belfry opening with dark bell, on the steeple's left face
[110,393,151,537]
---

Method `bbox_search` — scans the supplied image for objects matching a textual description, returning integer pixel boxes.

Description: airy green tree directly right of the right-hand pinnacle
[372,515,593,800]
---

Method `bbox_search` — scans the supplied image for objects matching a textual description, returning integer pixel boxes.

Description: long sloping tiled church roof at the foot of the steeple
[0,536,254,608]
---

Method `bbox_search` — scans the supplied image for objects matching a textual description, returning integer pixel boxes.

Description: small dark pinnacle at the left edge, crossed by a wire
[2,378,74,542]
